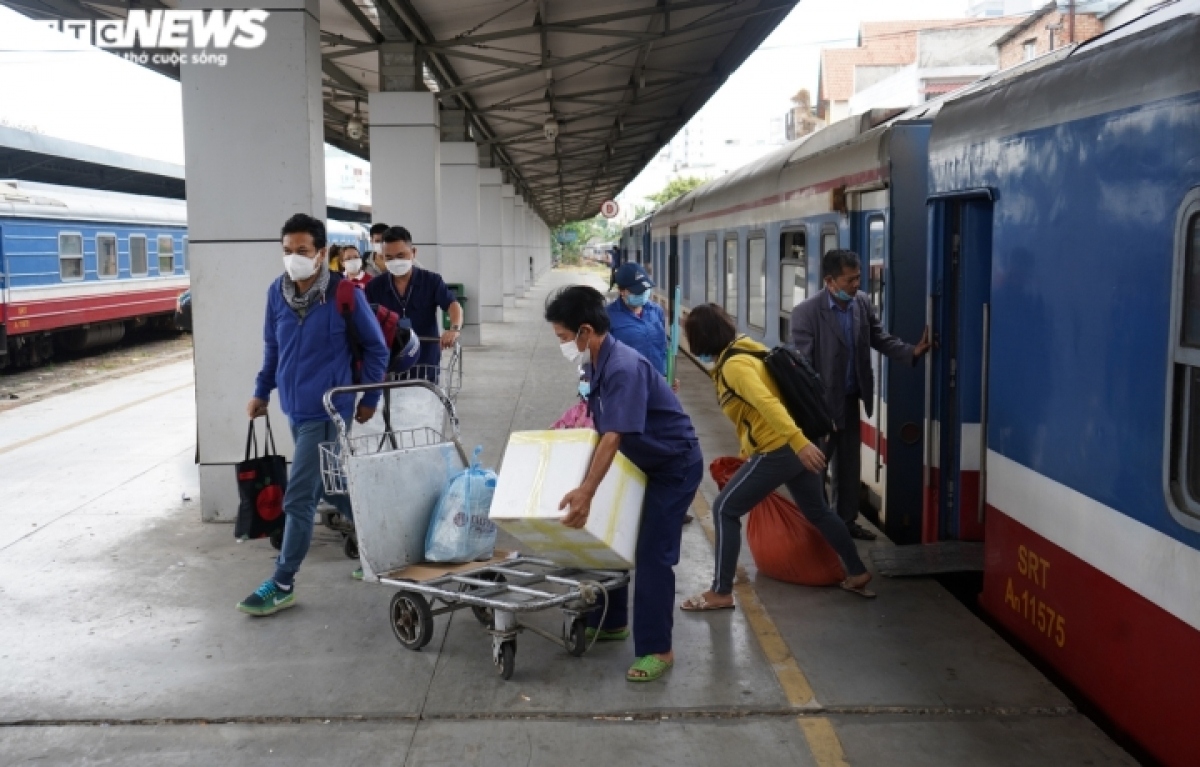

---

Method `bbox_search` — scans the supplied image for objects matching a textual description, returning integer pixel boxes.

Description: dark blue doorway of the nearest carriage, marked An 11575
[922,196,992,543]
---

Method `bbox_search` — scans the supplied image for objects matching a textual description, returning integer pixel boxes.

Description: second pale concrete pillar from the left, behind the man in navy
[368,91,442,271]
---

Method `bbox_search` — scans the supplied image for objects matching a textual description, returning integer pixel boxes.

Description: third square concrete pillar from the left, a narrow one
[438,142,482,346]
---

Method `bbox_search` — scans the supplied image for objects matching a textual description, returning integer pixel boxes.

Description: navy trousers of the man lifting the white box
[588,461,704,658]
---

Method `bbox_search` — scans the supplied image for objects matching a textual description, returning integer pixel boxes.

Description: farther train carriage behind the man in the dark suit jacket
[653,107,934,543]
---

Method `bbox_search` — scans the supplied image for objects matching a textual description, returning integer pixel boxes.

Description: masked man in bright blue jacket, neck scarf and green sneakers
[238,214,389,616]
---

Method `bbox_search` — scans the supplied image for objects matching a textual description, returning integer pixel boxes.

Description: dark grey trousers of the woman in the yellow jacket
[713,445,866,594]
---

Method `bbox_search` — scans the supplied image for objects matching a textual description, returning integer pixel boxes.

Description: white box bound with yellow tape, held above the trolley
[488,429,646,570]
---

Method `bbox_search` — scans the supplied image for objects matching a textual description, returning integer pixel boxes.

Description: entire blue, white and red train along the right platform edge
[620,0,1200,765]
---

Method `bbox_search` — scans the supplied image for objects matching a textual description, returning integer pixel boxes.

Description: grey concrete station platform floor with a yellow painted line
[0,269,1136,767]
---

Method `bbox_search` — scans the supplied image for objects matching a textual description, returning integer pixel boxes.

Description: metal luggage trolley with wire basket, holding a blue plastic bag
[320,380,629,679]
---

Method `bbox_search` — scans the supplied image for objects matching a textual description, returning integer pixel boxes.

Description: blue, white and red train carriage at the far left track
[0,181,187,367]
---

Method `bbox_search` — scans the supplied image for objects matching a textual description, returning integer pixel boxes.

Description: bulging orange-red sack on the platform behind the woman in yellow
[708,457,846,586]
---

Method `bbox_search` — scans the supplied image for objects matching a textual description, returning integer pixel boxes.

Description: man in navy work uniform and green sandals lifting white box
[546,286,703,682]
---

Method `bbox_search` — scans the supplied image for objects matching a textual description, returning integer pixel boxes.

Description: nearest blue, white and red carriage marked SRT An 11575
[926,0,1200,765]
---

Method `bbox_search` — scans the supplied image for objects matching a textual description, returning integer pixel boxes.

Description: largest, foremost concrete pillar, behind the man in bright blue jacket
[180,0,325,521]
